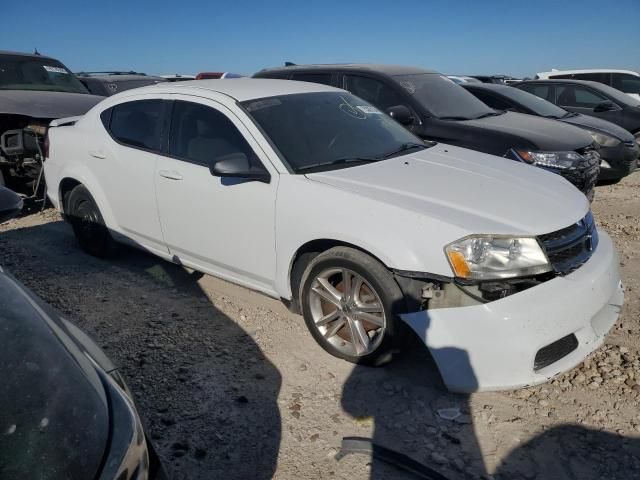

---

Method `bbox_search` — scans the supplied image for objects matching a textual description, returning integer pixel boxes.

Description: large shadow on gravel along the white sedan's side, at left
[0,222,281,479]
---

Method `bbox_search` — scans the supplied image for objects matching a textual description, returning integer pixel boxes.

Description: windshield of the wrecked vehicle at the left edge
[0,55,88,93]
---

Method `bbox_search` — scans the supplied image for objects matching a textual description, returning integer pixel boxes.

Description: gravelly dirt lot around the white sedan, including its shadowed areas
[0,173,640,480]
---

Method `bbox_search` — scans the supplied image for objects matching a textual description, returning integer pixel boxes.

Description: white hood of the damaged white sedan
[307,144,589,235]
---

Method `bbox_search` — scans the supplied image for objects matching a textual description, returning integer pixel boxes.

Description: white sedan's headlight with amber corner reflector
[445,235,552,280]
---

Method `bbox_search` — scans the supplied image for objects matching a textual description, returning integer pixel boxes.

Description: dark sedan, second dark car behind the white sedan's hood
[463,83,640,182]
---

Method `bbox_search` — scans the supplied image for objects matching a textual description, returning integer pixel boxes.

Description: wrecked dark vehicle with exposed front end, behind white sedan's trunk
[0,51,102,190]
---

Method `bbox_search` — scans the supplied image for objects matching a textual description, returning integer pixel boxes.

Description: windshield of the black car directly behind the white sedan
[393,73,496,120]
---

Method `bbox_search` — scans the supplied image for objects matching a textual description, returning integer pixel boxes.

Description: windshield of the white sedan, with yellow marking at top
[243,92,426,173]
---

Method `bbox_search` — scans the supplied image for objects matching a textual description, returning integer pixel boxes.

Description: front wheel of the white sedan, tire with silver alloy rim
[300,247,404,366]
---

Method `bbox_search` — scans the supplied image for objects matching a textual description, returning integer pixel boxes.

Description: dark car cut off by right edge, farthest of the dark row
[512,79,640,143]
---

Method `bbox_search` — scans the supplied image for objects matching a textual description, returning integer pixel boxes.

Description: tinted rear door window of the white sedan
[107,100,164,151]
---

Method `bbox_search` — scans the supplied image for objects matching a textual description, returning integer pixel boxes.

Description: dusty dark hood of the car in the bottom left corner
[0,269,109,480]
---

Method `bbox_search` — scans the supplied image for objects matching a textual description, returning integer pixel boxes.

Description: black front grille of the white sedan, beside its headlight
[539,212,598,275]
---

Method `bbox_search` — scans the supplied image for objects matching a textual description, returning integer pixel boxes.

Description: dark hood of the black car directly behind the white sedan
[456,112,593,151]
